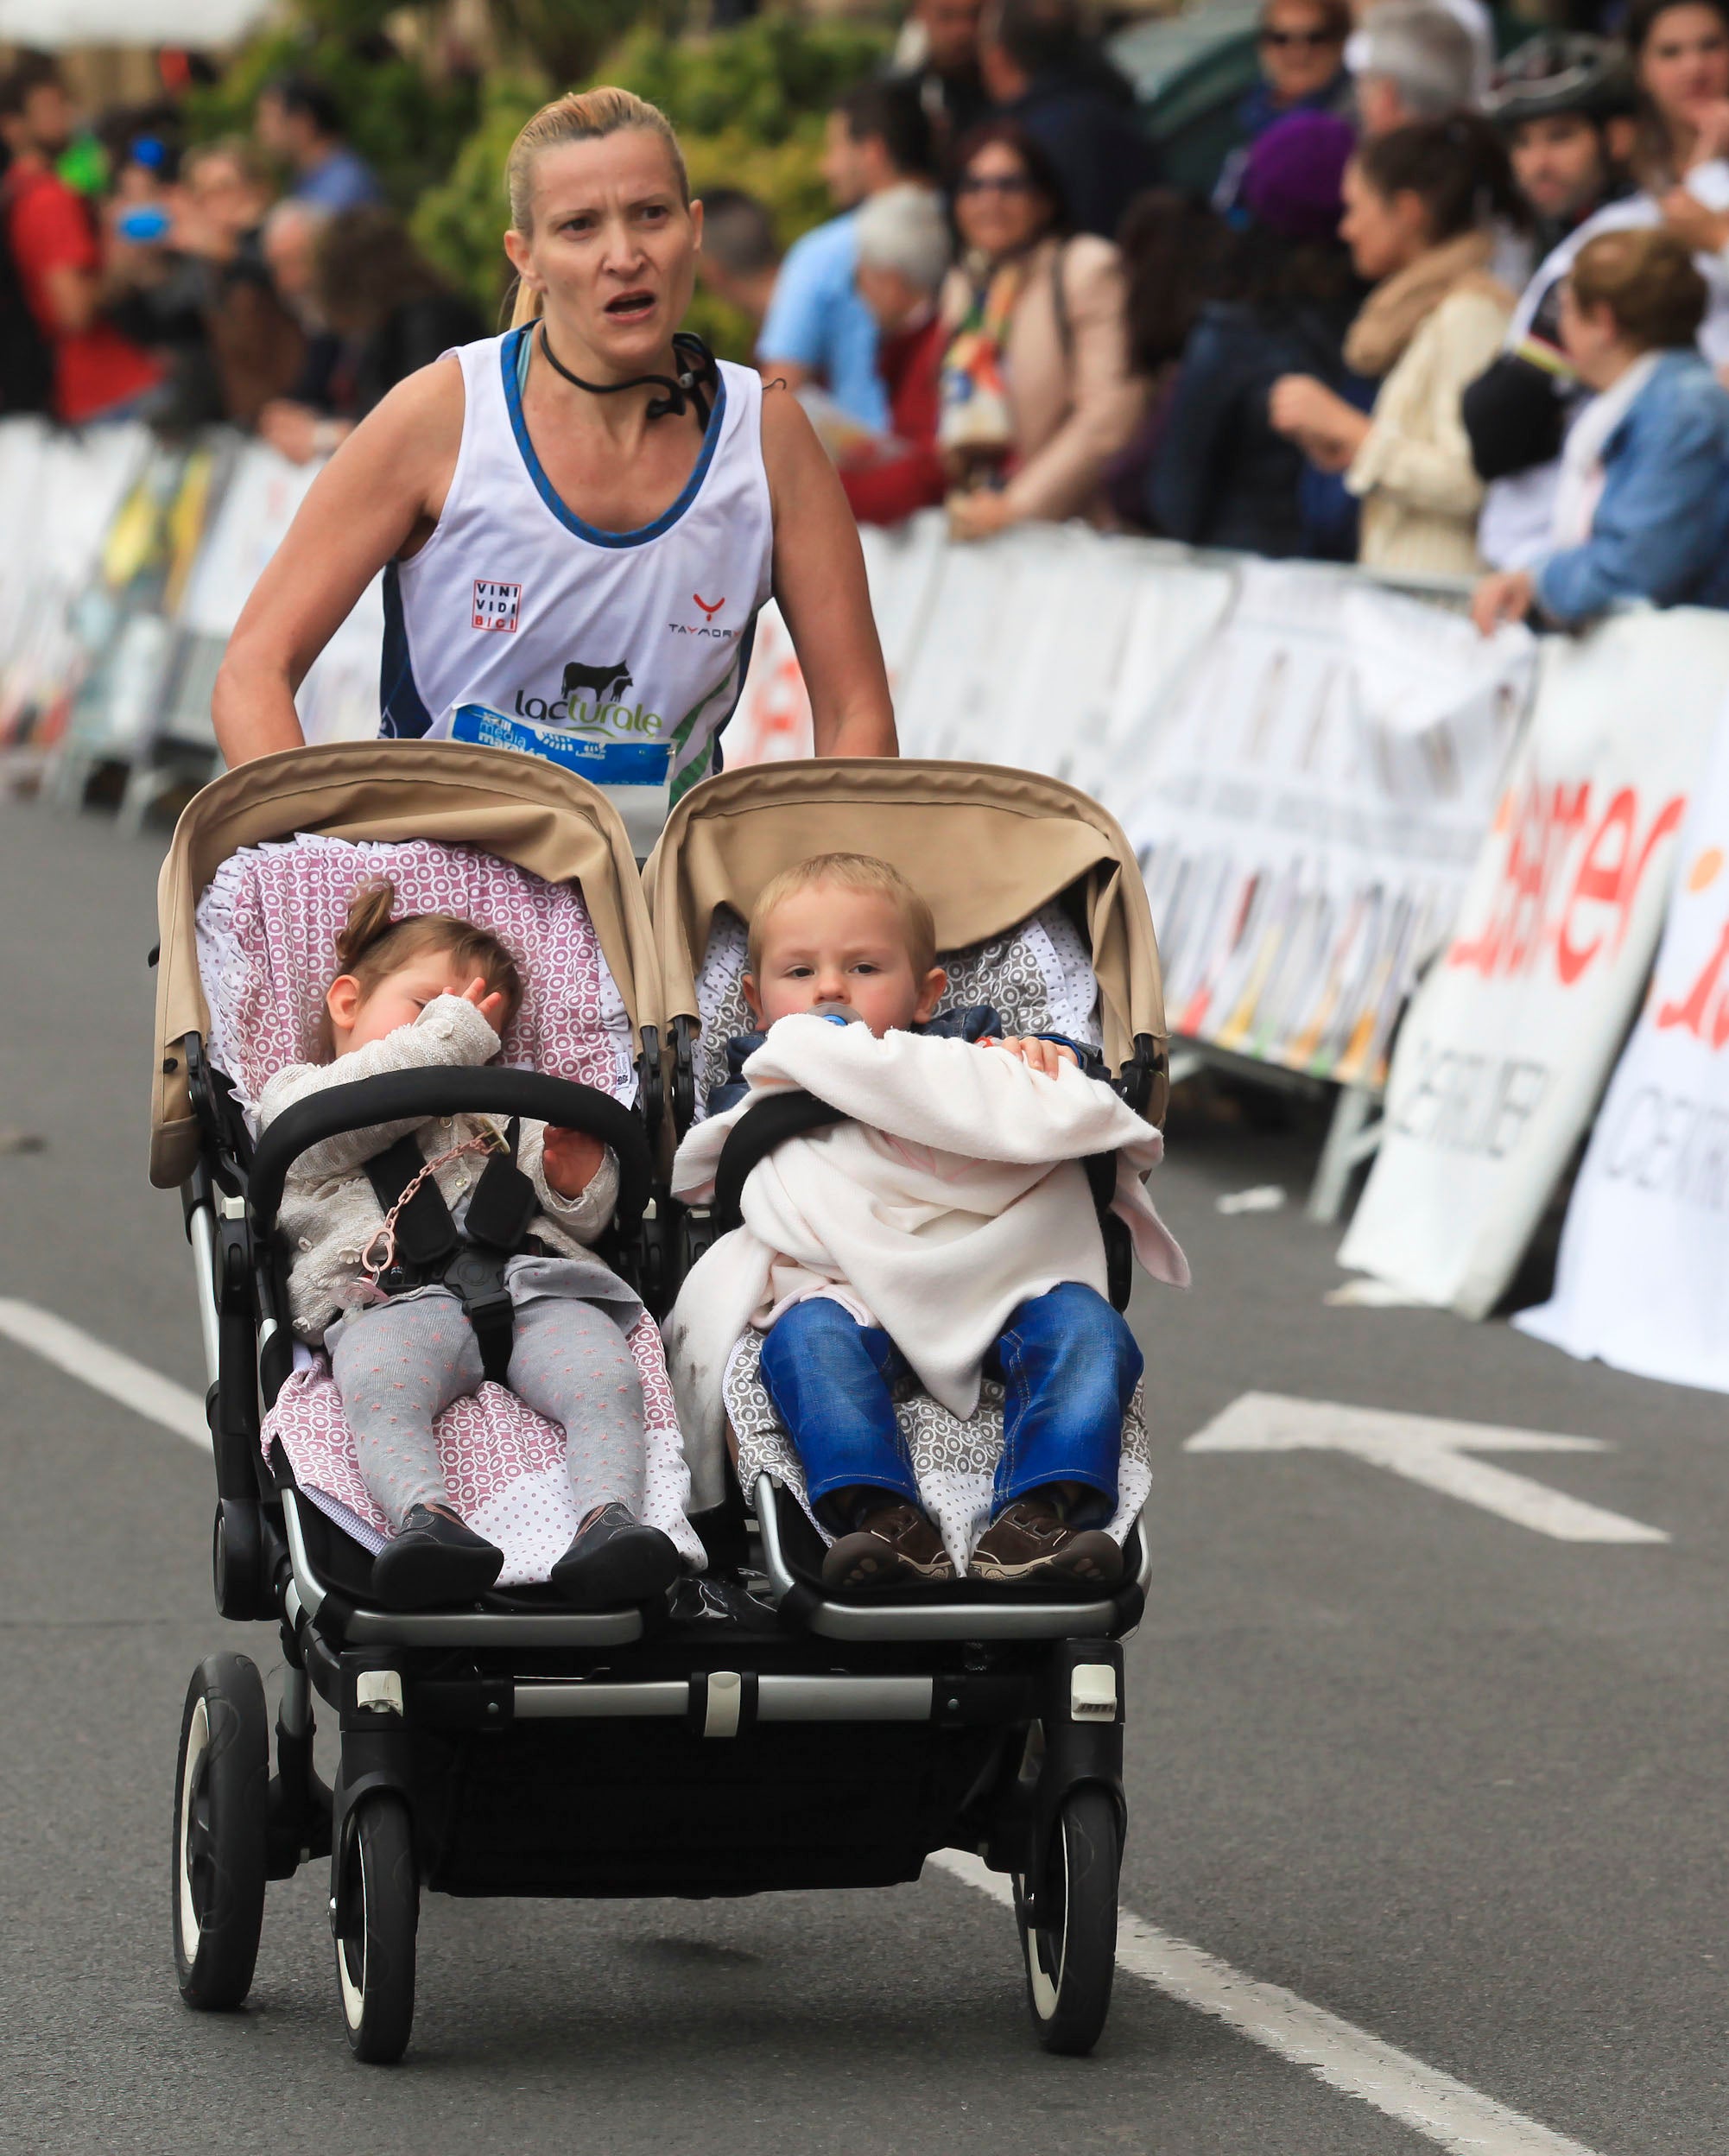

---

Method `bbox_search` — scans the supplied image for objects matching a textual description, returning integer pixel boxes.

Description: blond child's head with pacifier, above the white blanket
[744,884,948,1039]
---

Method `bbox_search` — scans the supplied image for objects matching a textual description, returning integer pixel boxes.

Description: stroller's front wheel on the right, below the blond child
[1016,1785,1124,2057]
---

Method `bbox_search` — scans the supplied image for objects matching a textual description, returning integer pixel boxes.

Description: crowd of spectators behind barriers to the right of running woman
[763,0,1729,631]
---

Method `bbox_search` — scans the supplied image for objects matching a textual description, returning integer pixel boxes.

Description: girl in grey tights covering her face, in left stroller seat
[259,882,679,1608]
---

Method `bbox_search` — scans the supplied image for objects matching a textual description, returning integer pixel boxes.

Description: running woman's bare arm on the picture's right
[763,390,899,757]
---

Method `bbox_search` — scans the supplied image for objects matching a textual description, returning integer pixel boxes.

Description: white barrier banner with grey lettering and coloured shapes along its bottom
[1106,562,1535,1084]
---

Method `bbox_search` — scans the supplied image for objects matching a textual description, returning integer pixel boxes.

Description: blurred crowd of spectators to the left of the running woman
[0,54,487,461]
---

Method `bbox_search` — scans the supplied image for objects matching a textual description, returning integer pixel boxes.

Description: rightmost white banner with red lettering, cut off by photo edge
[1513,709,1729,1392]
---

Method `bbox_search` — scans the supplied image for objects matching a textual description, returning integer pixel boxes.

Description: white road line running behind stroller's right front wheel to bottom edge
[931,1850,1593,2156]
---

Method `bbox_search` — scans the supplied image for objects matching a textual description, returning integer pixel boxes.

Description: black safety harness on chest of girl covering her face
[366,1117,542,1384]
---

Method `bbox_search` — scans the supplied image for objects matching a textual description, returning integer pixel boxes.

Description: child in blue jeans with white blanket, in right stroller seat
[668,853,1183,1594]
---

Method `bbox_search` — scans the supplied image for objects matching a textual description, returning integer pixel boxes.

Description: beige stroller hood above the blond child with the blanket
[643,757,1166,1094]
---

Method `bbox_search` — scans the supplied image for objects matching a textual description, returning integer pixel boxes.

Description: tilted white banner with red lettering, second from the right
[1339,608,1729,1317]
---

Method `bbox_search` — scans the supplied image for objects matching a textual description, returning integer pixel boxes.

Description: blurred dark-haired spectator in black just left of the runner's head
[259,209,487,464]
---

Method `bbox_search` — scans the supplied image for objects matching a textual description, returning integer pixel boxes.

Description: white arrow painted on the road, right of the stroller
[1183,1392,1669,1542]
